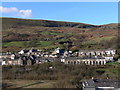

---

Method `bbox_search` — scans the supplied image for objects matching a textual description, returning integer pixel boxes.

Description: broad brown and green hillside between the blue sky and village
[1,18,118,52]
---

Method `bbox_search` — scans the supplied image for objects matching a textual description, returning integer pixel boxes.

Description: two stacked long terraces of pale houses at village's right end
[61,49,116,65]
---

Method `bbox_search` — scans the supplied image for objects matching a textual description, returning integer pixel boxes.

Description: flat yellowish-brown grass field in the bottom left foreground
[3,80,55,89]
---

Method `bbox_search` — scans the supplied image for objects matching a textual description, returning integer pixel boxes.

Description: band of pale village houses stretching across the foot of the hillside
[0,48,119,65]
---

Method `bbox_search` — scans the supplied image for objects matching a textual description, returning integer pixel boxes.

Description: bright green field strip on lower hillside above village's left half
[2,39,68,49]
